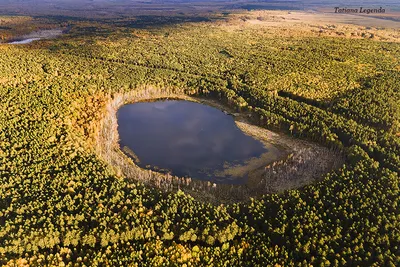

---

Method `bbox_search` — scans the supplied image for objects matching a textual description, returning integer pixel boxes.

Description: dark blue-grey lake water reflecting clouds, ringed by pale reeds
[117,100,267,184]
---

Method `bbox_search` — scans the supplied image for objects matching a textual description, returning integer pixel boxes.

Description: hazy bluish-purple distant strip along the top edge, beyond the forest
[0,0,400,16]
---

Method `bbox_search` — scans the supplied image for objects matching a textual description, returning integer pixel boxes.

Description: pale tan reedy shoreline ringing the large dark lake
[95,86,344,204]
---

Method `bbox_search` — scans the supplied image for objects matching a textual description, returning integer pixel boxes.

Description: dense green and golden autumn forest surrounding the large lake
[0,12,400,266]
